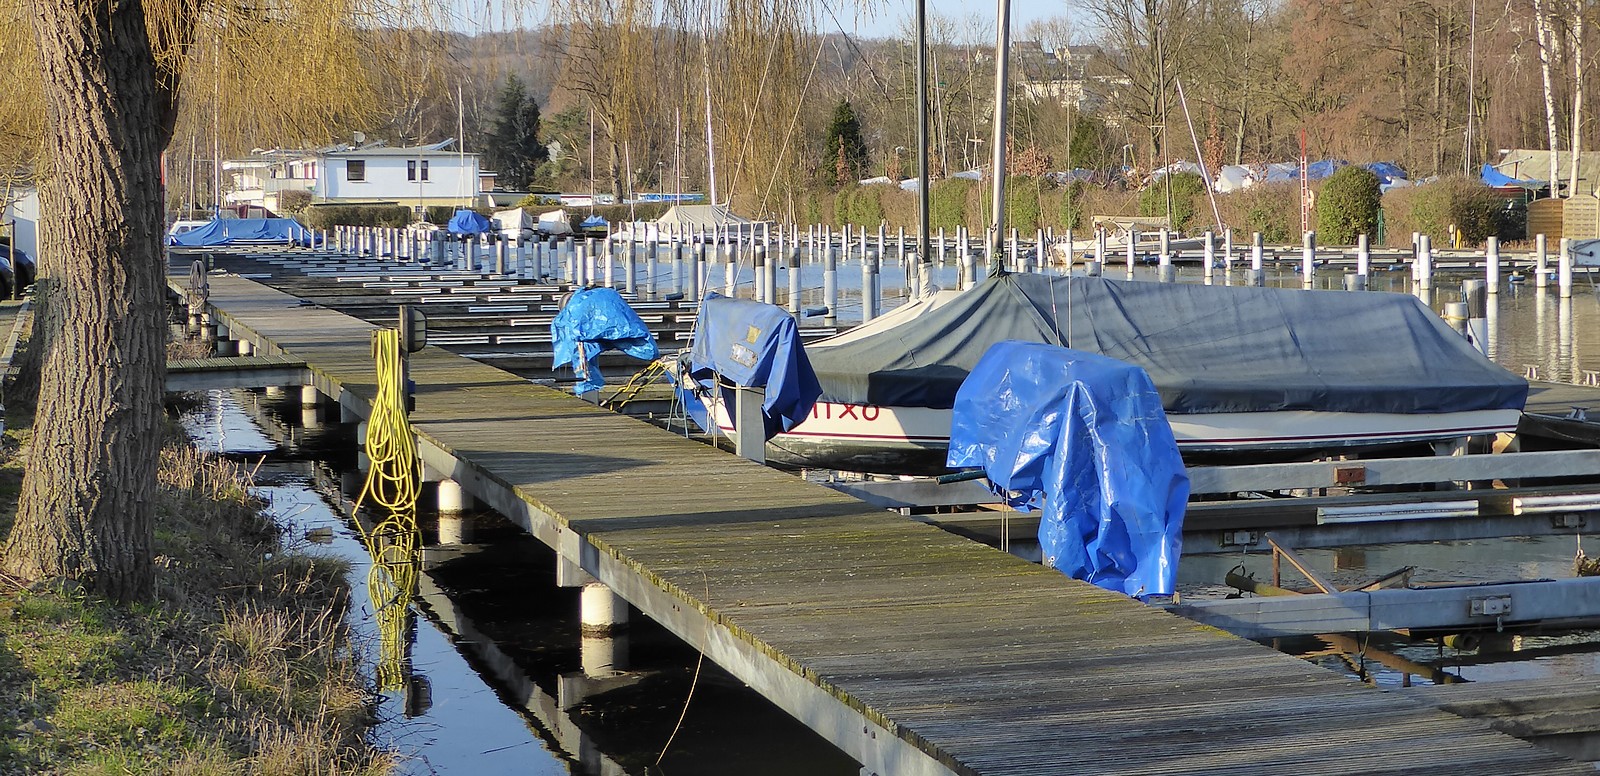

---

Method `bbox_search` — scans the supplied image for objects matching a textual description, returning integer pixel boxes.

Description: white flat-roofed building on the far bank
[222,139,480,211]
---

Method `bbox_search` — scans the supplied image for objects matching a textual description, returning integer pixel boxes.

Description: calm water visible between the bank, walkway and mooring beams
[175,262,1600,776]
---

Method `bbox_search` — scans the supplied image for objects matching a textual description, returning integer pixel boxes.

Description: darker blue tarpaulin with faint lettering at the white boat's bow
[685,293,822,438]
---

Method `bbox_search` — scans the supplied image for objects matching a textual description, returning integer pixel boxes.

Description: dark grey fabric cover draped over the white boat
[806,274,1528,414]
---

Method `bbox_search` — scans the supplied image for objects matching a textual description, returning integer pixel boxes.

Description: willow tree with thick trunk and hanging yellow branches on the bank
[0,0,438,602]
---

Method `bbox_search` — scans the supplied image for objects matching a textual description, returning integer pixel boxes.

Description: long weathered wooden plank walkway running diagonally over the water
[187,270,1594,776]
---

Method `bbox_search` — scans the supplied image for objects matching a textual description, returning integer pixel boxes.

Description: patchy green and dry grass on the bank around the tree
[0,422,397,776]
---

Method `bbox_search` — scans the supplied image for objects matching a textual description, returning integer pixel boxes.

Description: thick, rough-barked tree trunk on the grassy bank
[0,0,171,602]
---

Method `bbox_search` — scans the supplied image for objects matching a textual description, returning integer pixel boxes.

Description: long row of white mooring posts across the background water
[320,224,1573,323]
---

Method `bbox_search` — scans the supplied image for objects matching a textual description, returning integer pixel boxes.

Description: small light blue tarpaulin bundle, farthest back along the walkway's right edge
[550,288,659,395]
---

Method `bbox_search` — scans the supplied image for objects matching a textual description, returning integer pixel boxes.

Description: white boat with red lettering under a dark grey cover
[681,274,1528,474]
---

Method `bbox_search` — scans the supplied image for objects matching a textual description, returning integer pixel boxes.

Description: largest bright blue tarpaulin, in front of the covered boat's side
[947,339,1189,598]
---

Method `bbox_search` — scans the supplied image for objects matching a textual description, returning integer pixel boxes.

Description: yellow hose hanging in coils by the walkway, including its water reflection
[355,330,422,691]
